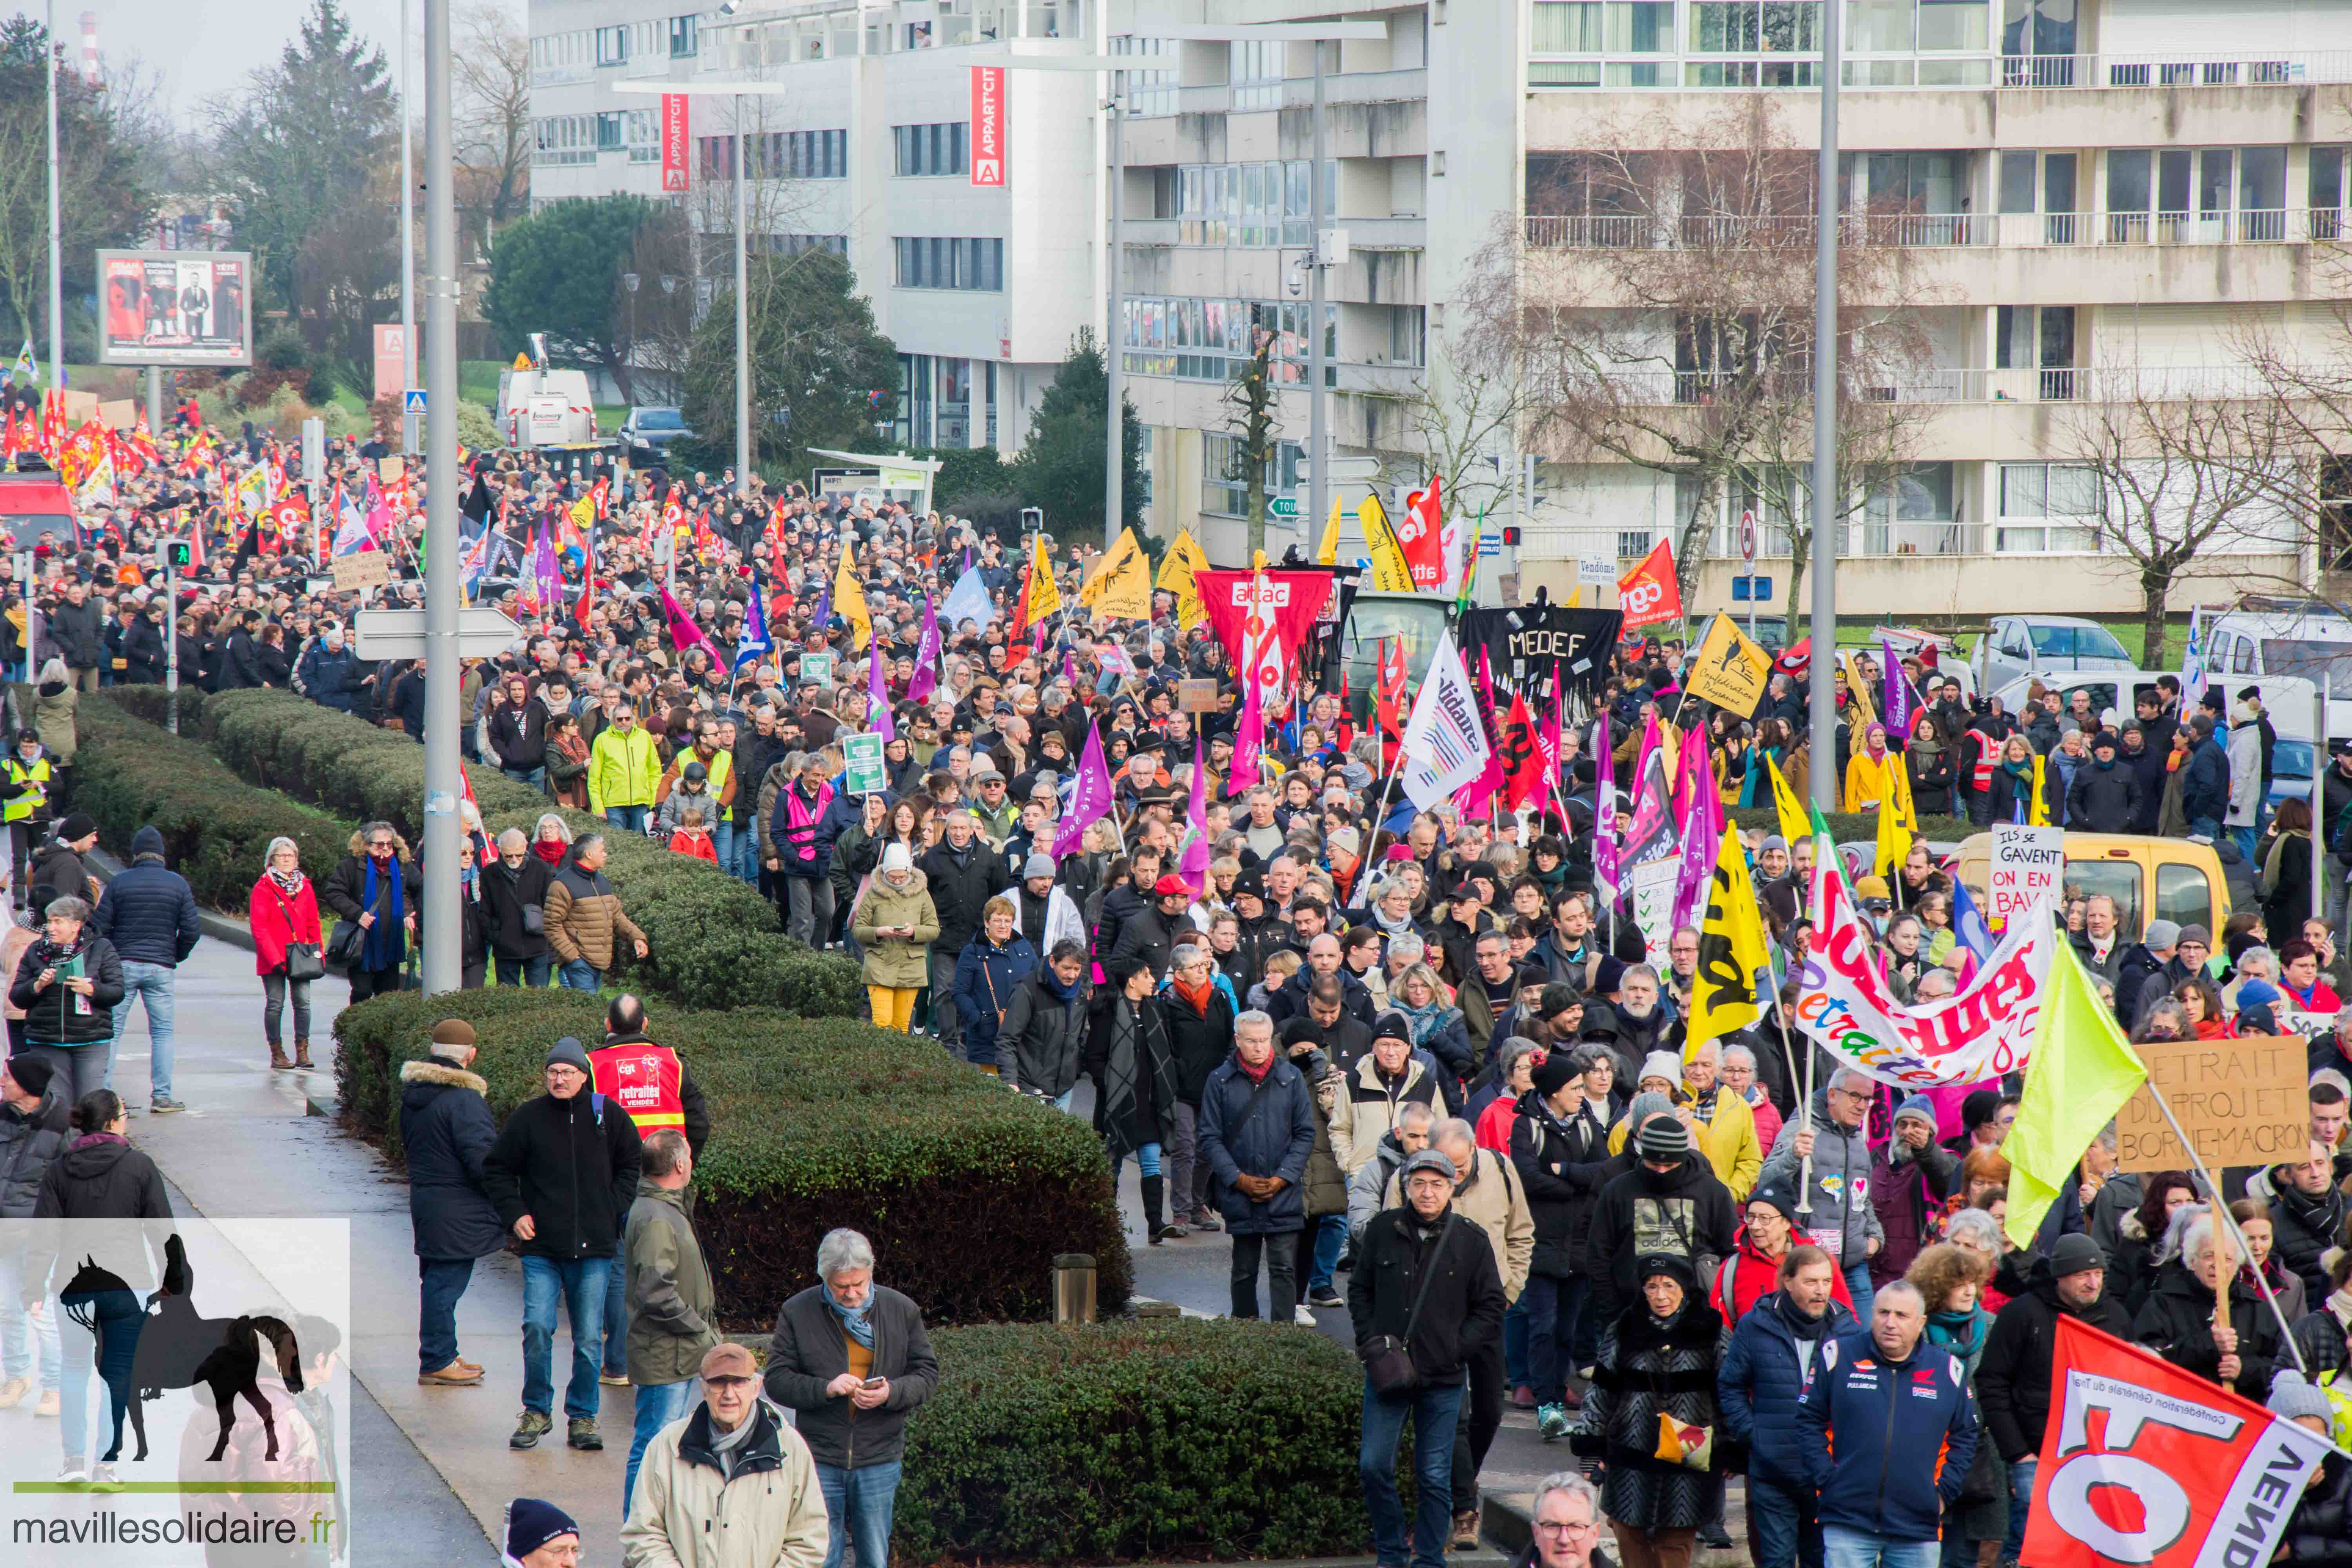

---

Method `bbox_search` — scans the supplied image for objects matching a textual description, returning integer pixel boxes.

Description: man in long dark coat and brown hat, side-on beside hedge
[400,1018,506,1389]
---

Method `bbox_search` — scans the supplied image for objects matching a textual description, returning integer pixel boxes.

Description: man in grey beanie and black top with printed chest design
[1585,1096,1740,1323]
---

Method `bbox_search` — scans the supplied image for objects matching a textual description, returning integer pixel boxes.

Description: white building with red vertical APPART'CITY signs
[529,0,1105,454]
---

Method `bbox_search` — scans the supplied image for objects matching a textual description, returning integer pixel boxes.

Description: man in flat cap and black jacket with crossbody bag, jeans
[1348,1150,1505,1568]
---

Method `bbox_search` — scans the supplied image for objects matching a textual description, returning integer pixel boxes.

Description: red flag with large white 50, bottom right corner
[2018,1312,2331,1568]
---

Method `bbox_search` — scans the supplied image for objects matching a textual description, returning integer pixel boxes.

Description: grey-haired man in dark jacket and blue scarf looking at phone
[767,1229,938,1568]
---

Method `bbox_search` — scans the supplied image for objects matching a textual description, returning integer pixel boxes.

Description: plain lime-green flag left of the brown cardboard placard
[2002,943,2147,1246]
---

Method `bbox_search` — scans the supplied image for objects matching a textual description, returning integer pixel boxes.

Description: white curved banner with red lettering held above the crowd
[1795,846,2060,1089]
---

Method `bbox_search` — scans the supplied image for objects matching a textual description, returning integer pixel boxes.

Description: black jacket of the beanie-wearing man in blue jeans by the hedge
[482,1089,644,1262]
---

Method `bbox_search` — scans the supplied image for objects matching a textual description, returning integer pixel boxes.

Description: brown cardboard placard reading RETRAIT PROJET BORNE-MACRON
[2114,1034,2312,1171]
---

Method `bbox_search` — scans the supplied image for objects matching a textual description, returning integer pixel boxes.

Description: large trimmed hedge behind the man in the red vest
[334,987,1134,1333]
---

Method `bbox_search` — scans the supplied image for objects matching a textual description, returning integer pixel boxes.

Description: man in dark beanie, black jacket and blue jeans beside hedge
[482,1034,642,1448]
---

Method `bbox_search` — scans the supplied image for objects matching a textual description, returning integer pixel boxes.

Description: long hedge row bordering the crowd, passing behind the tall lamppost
[111,686,866,1018]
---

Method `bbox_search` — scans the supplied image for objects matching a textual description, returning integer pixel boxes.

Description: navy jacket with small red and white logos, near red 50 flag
[1797,1328,1978,1542]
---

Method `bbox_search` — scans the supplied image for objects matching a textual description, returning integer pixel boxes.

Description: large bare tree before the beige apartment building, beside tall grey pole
[1463,99,1964,621]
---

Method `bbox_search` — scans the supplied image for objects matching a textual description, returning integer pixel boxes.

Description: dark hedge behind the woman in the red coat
[64,701,350,915]
